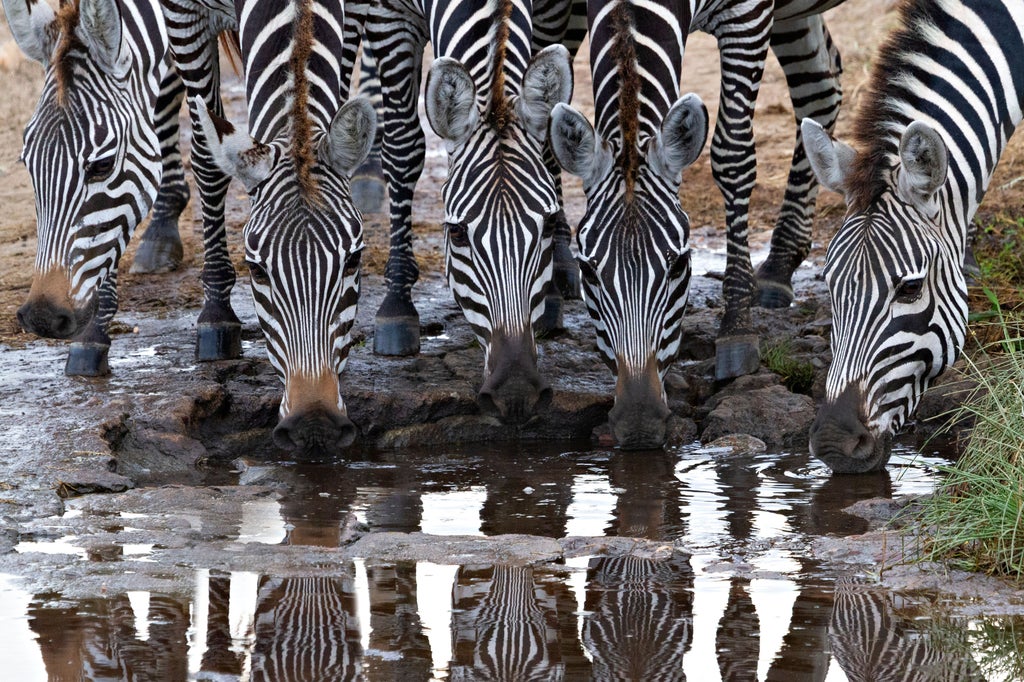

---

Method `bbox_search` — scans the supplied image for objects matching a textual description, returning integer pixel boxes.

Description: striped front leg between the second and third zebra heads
[366,17,427,355]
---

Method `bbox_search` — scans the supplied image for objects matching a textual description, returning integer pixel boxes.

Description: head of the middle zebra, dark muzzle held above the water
[426,45,572,424]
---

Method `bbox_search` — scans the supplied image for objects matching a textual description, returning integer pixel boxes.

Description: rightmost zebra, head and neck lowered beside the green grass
[802,0,1024,473]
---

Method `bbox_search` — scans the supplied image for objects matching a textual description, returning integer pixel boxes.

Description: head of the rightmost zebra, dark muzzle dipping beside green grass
[802,119,967,473]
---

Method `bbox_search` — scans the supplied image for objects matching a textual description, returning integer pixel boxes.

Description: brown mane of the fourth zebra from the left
[611,0,640,202]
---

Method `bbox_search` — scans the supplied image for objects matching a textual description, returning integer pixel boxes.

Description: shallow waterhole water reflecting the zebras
[0,444,1024,682]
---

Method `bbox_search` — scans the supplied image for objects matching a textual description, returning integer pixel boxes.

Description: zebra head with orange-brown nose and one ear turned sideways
[196,97,377,454]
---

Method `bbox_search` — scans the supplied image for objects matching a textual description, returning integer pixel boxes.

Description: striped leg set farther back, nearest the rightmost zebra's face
[757,14,843,308]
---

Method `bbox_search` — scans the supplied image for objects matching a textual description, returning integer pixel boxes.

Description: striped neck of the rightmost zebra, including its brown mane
[852,0,1024,246]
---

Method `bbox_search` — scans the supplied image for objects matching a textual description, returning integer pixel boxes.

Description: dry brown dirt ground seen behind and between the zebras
[0,0,1024,344]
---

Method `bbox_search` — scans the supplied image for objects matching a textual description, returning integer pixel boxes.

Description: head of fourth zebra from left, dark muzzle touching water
[551,94,708,449]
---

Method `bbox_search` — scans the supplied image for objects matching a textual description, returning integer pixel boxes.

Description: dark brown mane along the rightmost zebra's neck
[847,0,940,210]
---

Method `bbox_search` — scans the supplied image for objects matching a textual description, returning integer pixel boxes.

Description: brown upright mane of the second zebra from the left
[289,0,319,202]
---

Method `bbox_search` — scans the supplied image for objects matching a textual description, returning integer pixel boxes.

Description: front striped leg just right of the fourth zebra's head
[711,10,772,380]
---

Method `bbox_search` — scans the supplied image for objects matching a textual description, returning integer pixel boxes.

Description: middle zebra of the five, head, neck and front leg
[353,0,572,423]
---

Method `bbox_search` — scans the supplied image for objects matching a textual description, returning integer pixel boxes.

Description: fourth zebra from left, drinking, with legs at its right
[551,0,842,449]
